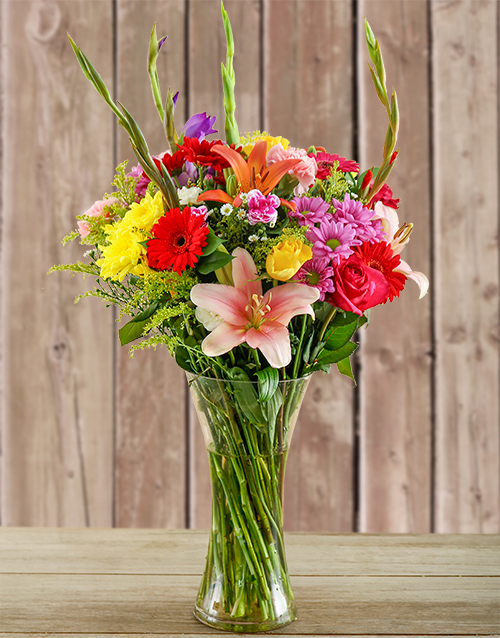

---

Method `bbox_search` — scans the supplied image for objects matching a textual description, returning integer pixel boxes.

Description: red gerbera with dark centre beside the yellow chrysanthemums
[148,206,210,275]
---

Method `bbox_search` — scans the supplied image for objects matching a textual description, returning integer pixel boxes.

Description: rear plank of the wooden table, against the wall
[0,528,500,577]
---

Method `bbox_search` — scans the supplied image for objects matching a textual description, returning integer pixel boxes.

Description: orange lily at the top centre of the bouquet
[198,140,301,206]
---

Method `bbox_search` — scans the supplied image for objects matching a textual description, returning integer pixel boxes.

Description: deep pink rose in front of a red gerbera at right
[326,255,390,315]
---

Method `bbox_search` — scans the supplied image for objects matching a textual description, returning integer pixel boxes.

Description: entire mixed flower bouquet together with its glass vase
[52,7,428,631]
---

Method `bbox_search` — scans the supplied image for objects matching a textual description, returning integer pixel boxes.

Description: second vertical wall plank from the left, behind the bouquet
[115,0,187,528]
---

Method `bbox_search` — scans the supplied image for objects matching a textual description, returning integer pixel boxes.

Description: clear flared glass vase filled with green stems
[187,373,309,632]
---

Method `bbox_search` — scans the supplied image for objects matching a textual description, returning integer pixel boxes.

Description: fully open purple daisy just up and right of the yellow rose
[306,218,362,263]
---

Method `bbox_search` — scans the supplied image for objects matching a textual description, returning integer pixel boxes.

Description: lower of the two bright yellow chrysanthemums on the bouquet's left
[97,228,151,281]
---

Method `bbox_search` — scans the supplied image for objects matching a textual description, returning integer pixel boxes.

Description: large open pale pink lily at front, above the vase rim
[191,248,319,368]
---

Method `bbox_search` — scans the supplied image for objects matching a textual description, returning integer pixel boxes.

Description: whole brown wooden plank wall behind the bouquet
[0,0,500,533]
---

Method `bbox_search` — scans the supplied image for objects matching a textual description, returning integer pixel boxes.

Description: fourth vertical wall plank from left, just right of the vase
[264,0,355,532]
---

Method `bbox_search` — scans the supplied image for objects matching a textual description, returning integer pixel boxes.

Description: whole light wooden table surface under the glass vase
[0,528,500,638]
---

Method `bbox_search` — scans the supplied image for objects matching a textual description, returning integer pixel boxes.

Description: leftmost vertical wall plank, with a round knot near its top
[0,0,113,526]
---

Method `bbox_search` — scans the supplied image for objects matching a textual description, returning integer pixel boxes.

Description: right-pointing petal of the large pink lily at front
[262,284,320,326]
